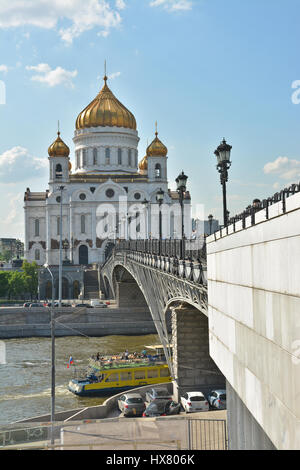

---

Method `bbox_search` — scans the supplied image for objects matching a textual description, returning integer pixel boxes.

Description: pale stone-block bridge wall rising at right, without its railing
[207,193,300,449]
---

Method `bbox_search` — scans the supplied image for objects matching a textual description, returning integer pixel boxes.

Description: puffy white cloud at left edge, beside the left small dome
[0,147,48,184]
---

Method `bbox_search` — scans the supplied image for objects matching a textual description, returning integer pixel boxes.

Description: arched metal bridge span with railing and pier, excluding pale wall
[101,240,225,398]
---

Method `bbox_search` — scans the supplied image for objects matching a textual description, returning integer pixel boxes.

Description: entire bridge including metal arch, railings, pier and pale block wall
[102,183,300,450]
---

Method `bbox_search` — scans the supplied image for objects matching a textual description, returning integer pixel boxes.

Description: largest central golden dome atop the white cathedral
[76,76,136,130]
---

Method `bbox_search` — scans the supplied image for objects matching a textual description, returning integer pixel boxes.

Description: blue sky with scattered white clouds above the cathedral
[0,0,300,240]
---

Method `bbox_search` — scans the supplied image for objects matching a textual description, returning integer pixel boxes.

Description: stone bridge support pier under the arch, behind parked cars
[172,304,225,400]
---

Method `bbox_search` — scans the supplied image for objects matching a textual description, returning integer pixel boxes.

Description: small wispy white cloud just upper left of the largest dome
[26,64,78,88]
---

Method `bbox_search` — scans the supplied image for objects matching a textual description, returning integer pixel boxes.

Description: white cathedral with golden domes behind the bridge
[24,76,190,297]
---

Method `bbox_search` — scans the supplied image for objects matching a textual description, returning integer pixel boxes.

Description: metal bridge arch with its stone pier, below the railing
[102,254,225,399]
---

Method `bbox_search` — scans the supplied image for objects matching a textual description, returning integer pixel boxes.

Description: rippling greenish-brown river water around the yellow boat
[0,335,159,425]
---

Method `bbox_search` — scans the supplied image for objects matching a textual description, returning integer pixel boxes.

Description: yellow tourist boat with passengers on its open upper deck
[68,348,172,397]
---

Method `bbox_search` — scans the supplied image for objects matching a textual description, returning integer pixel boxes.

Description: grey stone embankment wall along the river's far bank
[0,307,157,339]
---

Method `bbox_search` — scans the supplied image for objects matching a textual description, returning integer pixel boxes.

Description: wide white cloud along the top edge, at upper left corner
[0,0,125,44]
